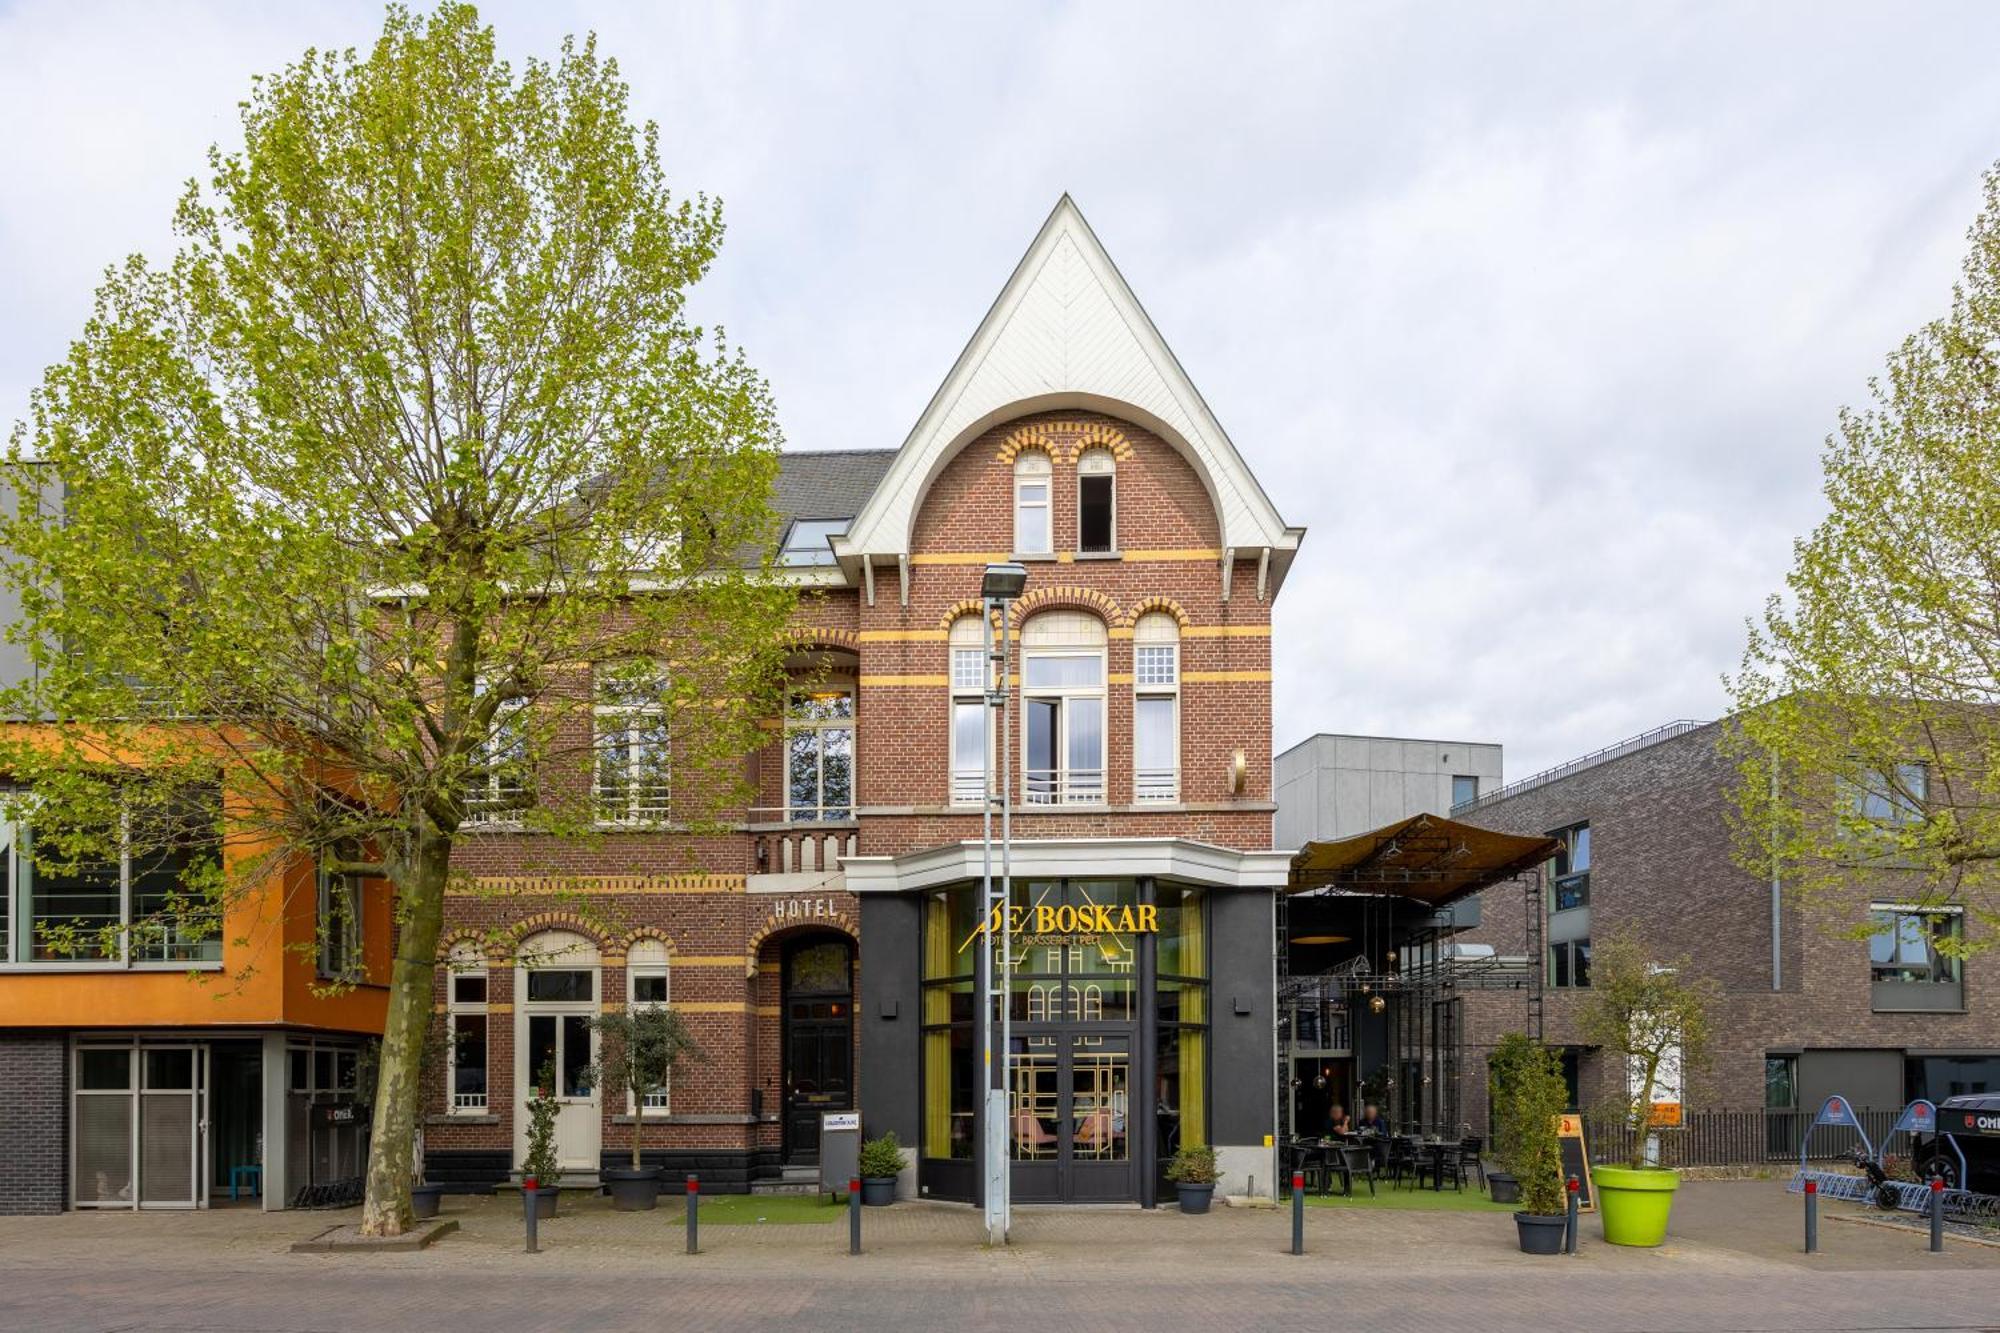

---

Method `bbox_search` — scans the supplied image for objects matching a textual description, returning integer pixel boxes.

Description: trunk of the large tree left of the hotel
[362,833,452,1235]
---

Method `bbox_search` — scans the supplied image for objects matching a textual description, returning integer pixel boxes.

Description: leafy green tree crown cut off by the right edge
[1730,168,2000,951]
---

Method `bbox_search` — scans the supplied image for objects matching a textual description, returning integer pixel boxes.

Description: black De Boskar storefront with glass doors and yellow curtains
[850,849,1274,1205]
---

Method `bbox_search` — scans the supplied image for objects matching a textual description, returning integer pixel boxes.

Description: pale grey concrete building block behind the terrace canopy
[1272,731,1502,847]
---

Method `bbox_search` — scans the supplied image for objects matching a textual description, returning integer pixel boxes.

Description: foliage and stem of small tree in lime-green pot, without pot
[1576,931,1722,1167]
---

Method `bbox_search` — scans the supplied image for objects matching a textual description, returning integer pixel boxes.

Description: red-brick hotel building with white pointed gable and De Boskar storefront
[426,200,1302,1199]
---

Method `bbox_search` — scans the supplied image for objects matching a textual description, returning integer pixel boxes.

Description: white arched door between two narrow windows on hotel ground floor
[514,931,604,1173]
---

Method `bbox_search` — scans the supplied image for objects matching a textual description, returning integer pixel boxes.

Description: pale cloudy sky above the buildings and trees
[0,0,2000,777]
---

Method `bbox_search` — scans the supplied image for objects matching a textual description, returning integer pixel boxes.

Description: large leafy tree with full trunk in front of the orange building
[0,4,794,1235]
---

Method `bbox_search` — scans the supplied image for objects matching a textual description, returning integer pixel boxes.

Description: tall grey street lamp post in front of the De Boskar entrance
[978,564,1028,1245]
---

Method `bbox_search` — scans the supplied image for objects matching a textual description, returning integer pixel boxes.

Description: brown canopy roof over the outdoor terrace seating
[1286,815,1556,909]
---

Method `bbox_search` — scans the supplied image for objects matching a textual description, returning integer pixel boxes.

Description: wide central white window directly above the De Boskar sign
[1020,610,1106,805]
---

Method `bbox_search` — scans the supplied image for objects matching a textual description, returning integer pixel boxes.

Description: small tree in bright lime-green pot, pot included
[1576,933,1718,1245]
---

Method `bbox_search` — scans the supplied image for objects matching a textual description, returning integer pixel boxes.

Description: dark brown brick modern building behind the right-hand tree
[1454,721,2000,1123]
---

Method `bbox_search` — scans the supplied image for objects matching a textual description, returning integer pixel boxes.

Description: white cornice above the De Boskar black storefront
[840,839,1292,893]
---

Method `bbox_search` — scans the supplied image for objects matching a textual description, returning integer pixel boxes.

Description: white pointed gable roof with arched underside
[834,194,1304,586]
